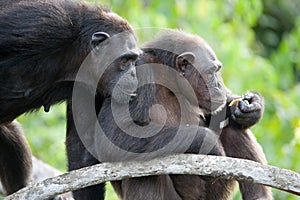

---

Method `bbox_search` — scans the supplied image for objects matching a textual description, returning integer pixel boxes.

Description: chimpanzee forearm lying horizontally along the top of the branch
[94,99,223,161]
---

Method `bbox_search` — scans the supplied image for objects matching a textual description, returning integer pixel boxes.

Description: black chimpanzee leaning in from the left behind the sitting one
[0,0,140,197]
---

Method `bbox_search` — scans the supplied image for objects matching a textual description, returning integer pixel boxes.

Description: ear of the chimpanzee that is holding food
[175,51,196,76]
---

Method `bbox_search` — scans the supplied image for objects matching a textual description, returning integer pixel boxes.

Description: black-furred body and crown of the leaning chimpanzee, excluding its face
[0,0,131,123]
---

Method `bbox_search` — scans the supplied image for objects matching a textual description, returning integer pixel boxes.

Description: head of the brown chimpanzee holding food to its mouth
[139,30,227,113]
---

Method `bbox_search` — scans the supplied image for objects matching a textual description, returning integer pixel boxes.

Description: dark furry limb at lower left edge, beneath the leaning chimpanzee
[0,121,32,194]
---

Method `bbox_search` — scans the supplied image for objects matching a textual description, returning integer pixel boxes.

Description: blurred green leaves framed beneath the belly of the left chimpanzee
[18,103,66,171]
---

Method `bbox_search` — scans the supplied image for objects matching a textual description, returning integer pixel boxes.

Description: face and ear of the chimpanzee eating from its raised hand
[175,41,226,113]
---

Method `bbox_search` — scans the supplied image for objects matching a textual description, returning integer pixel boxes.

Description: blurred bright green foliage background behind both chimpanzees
[18,0,300,200]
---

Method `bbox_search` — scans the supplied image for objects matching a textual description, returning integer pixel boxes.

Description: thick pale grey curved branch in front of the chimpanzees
[6,154,300,200]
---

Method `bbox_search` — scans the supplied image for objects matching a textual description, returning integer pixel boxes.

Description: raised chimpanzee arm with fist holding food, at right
[220,92,273,200]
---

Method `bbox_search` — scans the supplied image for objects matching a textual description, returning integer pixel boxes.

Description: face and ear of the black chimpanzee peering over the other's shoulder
[92,32,141,103]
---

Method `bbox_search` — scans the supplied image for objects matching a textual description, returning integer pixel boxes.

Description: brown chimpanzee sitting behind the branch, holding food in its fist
[67,30,272,200]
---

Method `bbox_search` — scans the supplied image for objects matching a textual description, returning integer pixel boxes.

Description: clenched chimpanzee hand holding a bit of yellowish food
[229,92,264,128]
